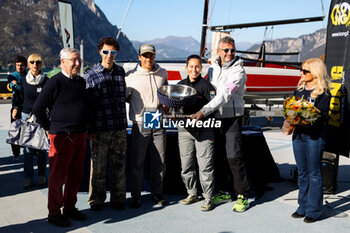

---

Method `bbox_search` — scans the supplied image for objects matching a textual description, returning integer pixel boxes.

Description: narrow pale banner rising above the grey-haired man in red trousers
[58,0,74,48]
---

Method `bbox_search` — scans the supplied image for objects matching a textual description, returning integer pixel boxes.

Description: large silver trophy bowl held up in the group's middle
[157,84,197,110]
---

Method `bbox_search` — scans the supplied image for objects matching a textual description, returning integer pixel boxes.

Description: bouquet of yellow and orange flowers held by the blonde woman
[282,96,320,134]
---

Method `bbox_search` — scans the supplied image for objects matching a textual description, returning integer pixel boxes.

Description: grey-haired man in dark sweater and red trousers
[33,48,89,227]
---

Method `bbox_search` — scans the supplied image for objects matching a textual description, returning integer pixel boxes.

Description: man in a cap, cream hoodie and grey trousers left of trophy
[126,44,168,208]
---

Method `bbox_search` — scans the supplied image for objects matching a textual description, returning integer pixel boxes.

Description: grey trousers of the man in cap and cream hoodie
[130,123,166,198]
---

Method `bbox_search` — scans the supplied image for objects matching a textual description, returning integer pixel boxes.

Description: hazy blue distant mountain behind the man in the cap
[132,36,200,59]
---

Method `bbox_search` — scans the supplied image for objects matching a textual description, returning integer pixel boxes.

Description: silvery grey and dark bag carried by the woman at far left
[6,116,50,151]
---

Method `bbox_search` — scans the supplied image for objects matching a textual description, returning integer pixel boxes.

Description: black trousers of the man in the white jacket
[214,117,250,196]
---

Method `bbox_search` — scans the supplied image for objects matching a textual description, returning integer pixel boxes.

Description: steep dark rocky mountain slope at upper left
[0,0,137,66]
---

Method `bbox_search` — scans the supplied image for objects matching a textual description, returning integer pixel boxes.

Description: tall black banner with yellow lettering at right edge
[326,0,350,156]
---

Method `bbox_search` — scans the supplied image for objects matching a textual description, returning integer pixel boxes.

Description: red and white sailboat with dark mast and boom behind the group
[121,0,325,103]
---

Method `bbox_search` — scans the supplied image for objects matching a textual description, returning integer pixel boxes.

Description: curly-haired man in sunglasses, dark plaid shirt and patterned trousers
[85,37,127,211]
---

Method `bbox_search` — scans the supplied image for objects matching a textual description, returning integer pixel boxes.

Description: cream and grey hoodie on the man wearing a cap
[125,63,168,124]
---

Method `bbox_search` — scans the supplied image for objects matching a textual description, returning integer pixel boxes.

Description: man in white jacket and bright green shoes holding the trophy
[192,37,250,212]
